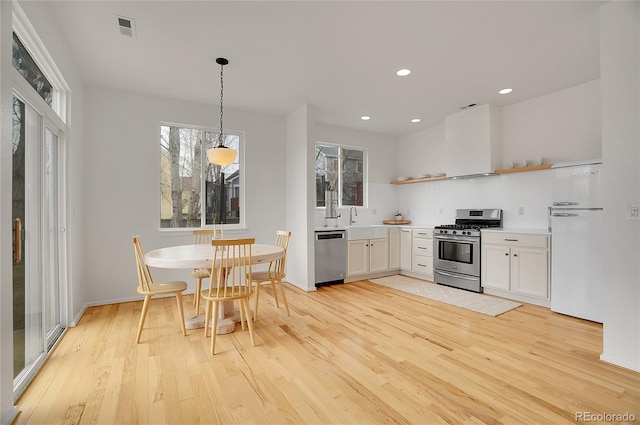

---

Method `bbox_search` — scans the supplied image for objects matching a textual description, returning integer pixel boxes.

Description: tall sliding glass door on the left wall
[12,94,62,394]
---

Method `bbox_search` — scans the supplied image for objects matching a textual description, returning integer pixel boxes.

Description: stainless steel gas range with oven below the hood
[433,209,502,292]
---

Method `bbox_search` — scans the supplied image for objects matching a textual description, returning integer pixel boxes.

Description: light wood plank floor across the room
[15,281,640,424]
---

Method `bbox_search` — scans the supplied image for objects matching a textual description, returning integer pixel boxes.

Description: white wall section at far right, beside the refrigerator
[600,1,640,371]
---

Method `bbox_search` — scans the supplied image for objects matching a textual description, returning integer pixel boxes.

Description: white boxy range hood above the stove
[444,105,502,178]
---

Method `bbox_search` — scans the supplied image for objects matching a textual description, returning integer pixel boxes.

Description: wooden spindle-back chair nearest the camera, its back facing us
[202,238,256,354]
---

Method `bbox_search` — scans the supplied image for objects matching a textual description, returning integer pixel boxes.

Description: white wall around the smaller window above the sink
[313,123,398,227]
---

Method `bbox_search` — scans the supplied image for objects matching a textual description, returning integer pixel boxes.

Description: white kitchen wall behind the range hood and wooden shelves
[397,81,602,229]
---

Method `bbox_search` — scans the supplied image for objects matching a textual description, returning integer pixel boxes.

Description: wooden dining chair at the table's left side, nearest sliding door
[132,236,187,344]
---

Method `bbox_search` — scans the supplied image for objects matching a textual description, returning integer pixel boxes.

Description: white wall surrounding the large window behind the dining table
[78,86,286,303]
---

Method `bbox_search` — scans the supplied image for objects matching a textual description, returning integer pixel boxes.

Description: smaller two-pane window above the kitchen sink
[316,144,366,207]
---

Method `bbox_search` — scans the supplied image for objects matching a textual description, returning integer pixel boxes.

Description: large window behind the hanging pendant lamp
[160,125,243,228]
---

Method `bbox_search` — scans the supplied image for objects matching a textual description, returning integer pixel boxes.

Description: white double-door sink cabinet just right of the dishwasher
[347,239,389,277]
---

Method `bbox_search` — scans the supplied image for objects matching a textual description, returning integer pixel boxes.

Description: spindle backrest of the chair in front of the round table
[209,238,256,299]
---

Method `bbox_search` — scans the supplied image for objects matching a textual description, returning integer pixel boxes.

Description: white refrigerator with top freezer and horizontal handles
[549,160,605,323]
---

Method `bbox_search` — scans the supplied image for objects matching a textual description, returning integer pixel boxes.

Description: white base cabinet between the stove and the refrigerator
[481,231,550,306]
